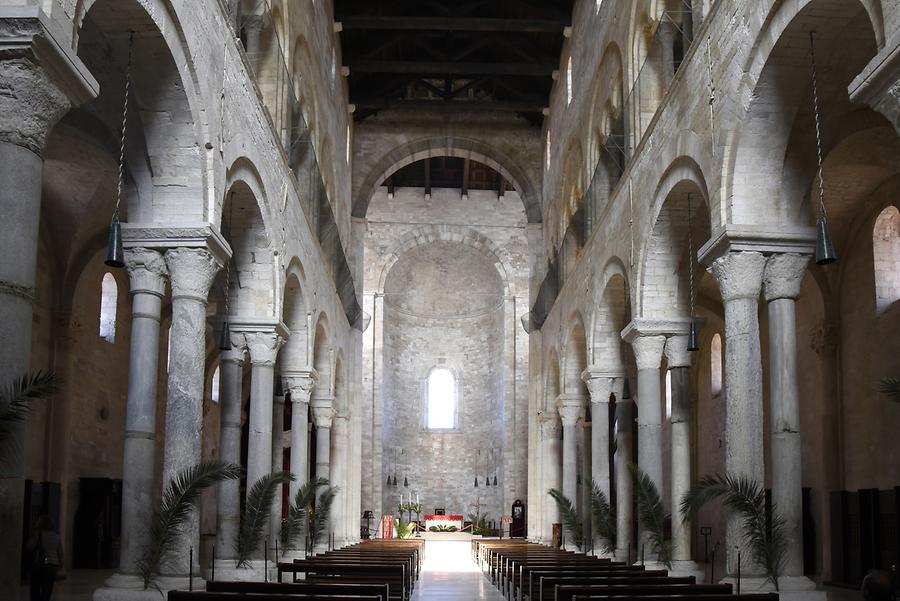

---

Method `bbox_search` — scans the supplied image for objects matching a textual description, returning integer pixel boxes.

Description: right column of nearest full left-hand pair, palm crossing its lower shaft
[162,247,222,576]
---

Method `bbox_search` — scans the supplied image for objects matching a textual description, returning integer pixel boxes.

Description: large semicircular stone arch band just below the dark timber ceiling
[352,136,541,223]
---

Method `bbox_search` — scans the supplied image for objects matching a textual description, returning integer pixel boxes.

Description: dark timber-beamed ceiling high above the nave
[335,0,574,125]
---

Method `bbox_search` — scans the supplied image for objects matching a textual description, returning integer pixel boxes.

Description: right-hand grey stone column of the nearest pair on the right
[763,253,809,577]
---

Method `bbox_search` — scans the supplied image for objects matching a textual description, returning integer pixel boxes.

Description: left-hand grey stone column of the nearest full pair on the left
[119,248,168,575]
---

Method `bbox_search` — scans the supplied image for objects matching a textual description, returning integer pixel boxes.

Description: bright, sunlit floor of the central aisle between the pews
[410,540,503,601]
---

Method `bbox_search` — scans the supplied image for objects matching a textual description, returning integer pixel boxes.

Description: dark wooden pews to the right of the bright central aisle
[472,539,778,601]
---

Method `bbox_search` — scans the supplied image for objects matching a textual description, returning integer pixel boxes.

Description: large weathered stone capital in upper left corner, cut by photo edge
[0,6,100,156]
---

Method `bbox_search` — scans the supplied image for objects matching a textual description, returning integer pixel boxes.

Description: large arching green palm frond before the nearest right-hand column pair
[681,474,787,591]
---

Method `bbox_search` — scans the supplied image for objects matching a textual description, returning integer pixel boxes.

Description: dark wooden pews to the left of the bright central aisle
[168,539,425,601]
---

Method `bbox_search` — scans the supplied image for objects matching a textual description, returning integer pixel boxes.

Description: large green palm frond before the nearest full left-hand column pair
[137,461,241,590]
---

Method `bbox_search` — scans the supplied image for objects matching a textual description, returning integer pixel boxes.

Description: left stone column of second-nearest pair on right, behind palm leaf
[630,333,666,495]
